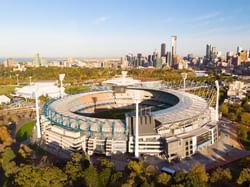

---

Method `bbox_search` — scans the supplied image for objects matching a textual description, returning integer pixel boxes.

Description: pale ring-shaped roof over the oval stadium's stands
[45,88,208,133]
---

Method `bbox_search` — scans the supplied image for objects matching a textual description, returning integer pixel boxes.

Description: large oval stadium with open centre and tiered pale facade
[37,74,218,161]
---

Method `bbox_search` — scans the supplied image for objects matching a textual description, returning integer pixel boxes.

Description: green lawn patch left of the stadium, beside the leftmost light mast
[16,121,36,142]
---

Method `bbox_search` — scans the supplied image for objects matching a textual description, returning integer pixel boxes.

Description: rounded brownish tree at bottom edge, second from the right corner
[210,168,232,184]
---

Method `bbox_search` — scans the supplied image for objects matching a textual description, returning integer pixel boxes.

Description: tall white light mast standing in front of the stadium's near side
[134,92,141,158]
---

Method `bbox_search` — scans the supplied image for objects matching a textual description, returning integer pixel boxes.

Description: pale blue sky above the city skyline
[0,0,250,58]
